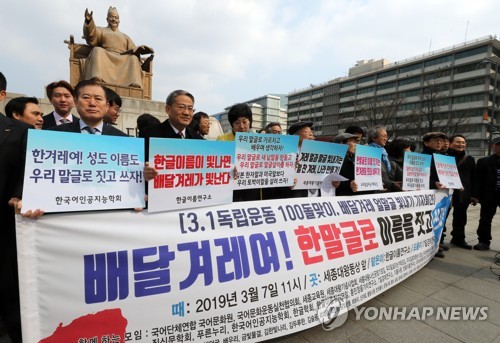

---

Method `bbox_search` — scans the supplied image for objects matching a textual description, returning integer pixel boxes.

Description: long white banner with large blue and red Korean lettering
[17,191,450,343]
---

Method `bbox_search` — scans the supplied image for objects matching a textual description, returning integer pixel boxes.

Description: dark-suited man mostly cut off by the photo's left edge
[0,73,31,343]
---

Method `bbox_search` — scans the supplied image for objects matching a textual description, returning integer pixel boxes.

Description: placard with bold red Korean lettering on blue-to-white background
[148,138,234,212]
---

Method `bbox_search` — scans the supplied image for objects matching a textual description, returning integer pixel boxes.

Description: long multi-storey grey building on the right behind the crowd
[288,36,500,156]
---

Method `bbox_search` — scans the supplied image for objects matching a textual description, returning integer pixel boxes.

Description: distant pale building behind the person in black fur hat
[214,94,288,136]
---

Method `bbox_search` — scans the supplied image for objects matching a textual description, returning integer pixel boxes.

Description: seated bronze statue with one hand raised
[82,7,154,88]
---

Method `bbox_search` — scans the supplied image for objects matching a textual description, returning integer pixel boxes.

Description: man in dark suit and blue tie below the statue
[49,80,127,136]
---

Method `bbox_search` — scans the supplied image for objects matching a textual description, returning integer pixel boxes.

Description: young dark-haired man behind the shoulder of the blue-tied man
[42,80,78,130]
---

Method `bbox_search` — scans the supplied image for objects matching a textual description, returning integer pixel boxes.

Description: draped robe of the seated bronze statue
[82,20,142,87]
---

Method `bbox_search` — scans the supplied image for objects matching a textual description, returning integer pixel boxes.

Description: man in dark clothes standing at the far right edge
[473,137,500,250]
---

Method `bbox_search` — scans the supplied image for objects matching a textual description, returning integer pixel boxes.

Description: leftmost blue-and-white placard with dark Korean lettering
[23,130,145,212]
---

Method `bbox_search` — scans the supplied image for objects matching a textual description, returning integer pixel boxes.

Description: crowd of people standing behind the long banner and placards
[0,73,500,342]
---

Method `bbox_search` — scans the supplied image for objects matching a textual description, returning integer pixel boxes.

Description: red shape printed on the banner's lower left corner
[39,309,127,343]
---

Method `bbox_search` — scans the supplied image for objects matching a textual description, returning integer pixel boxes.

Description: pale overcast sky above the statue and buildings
[0,0,500,114]
